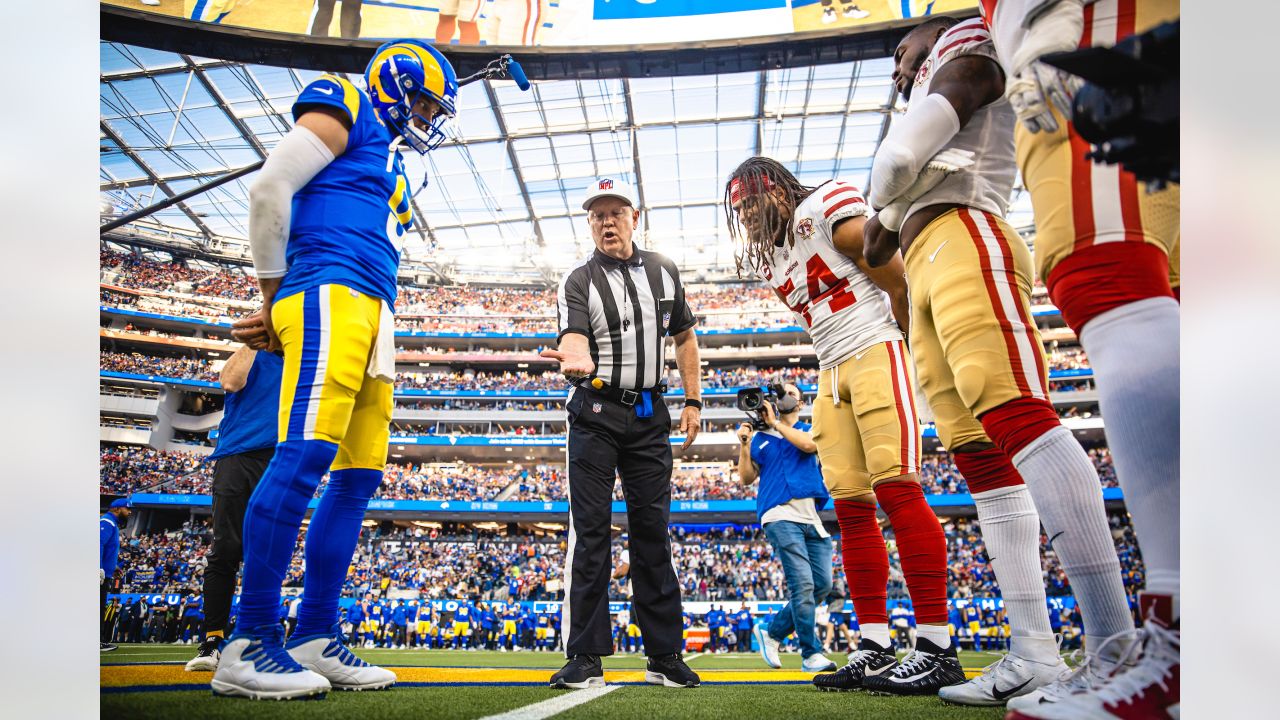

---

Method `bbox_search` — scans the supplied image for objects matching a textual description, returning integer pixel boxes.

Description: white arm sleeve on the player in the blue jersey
[248,126,334,278]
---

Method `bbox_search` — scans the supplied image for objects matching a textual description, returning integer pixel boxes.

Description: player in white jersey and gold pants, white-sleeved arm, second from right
[865,18,1133,705]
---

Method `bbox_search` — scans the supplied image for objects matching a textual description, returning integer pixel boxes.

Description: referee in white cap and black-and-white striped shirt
[543,177,703,688]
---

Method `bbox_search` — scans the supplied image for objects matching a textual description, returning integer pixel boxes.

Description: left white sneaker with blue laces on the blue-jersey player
[209,624,330,700]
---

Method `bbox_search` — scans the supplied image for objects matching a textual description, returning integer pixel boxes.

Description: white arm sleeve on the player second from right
[868,94,960,210]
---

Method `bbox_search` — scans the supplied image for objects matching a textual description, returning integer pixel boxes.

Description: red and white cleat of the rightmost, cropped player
[1009,623,1181,720]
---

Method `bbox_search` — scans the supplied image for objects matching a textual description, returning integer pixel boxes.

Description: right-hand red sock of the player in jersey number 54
[859,482,947,625]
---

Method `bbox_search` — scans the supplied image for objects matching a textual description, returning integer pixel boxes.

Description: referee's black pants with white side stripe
[562,388,684,657]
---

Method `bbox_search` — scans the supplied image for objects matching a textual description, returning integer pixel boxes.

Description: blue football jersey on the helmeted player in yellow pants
[276,74,413,304]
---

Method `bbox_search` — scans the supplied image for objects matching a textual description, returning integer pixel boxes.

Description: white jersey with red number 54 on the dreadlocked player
[760,181,902,370]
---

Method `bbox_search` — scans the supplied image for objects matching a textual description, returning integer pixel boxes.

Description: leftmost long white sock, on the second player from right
[973,486,1057,662]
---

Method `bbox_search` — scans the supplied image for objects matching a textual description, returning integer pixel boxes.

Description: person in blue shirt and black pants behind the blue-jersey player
[186,346,284,673]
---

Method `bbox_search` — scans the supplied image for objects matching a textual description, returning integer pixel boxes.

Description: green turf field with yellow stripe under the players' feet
[101,644,1004,720]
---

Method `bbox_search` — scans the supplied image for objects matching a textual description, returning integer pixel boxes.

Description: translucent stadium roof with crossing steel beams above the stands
[100,37,1030,282]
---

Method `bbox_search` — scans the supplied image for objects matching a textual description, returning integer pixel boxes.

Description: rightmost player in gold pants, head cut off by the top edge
[982,0,1181,719]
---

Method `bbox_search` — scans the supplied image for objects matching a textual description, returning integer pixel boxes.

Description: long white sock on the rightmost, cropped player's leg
[1080,297,1181,607]
